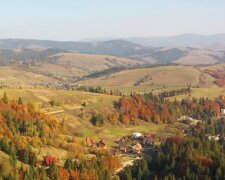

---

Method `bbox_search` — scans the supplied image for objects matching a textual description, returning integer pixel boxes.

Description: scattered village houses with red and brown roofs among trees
[33,109,225,172]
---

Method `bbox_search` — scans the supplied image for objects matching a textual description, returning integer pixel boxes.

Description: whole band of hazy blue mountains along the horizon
[0,34,225,65]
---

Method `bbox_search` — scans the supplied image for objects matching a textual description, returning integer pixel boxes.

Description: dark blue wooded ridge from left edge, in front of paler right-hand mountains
[0,39,185,63]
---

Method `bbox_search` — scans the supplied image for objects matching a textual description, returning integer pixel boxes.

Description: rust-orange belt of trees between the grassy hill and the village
[108,90,225,125]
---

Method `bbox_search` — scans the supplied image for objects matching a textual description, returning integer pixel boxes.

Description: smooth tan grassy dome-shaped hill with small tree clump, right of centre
[81,66,215,94]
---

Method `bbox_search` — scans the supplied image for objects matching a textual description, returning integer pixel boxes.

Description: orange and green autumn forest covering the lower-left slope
[0,93,121,180]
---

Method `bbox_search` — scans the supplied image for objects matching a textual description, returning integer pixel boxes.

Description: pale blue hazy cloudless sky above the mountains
[0,0,225,41]
